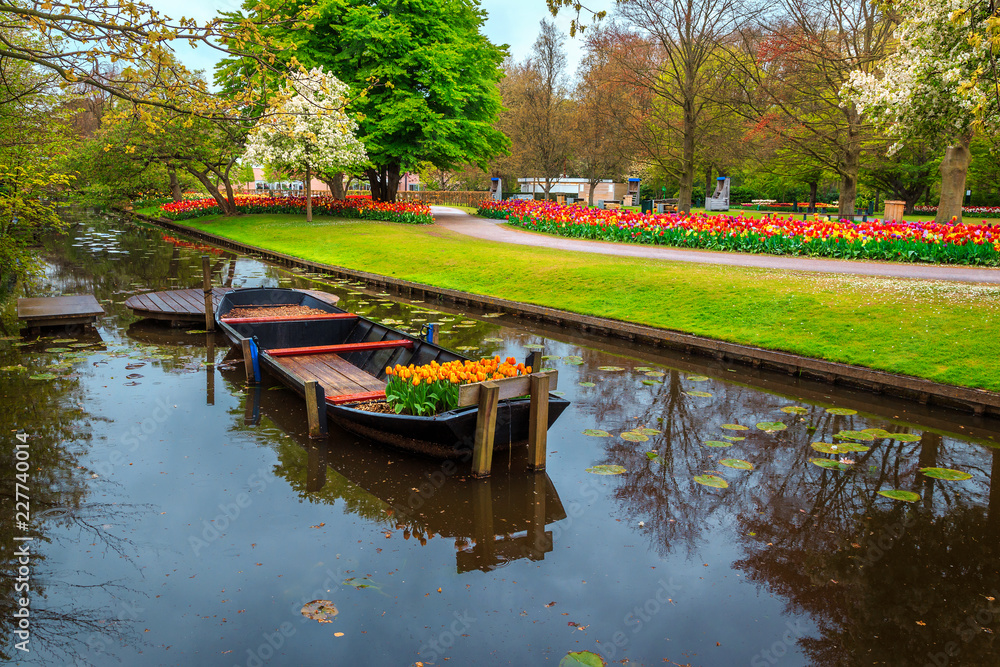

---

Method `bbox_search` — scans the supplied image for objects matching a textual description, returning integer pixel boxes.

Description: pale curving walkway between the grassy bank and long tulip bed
[431,206,1000,285]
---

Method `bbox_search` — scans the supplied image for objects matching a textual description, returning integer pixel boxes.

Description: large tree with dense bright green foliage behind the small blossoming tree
[219,0,508,201]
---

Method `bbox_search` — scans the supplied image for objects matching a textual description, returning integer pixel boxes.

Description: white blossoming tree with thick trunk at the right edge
[845,0,1000,222]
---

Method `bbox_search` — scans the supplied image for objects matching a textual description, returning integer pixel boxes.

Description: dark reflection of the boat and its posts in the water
[229,370,566,572]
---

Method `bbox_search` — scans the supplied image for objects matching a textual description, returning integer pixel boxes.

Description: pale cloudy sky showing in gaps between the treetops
[147,0,611,82]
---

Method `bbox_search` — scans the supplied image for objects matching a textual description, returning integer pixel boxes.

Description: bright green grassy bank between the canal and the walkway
[185,215,1000,391]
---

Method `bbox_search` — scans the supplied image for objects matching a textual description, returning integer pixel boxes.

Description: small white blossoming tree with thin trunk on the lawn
[243,69,368,222]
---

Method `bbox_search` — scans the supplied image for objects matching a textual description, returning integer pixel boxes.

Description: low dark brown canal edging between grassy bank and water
[129,211,1000,416]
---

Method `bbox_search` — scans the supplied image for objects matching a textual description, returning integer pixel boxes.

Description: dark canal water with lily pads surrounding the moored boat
[0,211,1000,666]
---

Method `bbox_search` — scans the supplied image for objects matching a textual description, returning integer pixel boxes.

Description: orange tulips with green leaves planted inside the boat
[385,356,531,415]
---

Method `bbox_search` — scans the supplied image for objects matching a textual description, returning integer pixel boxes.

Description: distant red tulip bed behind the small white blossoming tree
[160,195,434,225]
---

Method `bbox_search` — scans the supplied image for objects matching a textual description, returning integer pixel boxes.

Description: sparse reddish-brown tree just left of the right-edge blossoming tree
[732,0,894,215]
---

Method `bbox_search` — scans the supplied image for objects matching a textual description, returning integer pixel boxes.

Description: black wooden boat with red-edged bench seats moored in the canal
[215,288,569,458]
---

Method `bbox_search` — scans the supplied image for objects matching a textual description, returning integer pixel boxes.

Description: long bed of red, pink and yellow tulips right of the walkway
[479,201,1000,266]
